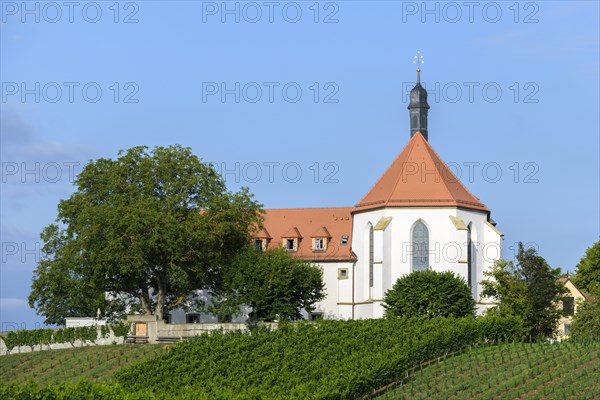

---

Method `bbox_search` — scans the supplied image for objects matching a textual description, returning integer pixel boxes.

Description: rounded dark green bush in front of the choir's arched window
[383,270,475,318]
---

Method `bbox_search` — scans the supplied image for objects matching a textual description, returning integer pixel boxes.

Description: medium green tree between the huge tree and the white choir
[211,248,325,322]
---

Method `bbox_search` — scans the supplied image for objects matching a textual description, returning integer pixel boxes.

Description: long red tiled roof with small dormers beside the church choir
[255,207,355,261]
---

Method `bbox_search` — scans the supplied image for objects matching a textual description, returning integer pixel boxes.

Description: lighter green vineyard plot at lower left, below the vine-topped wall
[0,344,168,384]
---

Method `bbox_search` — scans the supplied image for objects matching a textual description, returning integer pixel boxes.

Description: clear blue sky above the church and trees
[0,1,600,330]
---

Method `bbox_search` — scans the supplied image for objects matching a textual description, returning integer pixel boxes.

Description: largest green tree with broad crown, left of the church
[29,146,261,323]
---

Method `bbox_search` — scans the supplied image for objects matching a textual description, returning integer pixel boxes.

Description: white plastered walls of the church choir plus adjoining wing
[317,207,503,319]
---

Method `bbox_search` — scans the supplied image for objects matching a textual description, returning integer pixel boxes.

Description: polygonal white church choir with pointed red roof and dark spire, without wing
[346,53,502,318]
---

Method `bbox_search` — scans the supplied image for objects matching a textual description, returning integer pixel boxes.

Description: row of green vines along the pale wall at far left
[0,322,130,352]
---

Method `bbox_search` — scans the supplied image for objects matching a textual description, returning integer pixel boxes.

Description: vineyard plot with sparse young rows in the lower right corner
[377,341,600,400]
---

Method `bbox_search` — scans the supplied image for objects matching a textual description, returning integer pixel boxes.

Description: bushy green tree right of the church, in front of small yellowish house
[482,243,566,339]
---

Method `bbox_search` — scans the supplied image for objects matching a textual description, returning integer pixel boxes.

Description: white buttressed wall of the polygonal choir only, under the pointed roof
[352,207,502,318]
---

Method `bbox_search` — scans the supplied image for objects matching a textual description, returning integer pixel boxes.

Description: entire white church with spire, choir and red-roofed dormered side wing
[254,68,503,319]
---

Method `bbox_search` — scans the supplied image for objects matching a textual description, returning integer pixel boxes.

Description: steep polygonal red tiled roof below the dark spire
[352,132,489,213]
